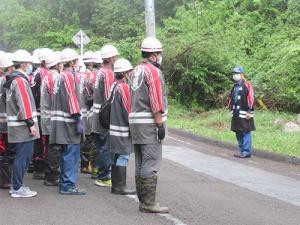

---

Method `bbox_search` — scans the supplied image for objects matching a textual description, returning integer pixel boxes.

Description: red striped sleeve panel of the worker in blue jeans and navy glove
[62,72,80,114]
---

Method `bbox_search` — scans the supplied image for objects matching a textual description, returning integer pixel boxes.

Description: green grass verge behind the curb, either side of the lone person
[168,100,300,157]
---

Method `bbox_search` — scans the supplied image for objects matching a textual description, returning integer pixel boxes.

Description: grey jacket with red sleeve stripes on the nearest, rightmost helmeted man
[129,59,168,144]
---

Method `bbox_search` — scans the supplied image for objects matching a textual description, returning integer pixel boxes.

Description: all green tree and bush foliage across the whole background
[0,0,300,113]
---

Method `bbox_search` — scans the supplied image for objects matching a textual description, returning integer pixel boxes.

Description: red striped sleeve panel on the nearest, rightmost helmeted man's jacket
[144,64,163,113]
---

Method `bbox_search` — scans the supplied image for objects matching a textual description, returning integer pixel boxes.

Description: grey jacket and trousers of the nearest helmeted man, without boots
[129,60,168,177]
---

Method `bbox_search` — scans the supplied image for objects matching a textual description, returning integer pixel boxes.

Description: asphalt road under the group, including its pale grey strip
[0,134,300,225]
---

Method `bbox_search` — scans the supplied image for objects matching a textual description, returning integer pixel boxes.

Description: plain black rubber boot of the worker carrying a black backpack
[111,165,136,195]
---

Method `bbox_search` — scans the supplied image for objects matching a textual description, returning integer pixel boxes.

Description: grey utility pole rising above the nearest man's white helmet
[145,0,156,37]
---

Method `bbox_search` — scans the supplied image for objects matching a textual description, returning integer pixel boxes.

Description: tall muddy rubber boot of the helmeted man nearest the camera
[140,176,169,213]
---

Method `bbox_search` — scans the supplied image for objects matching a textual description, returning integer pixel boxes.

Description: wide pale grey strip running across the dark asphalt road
[163,146,300,206]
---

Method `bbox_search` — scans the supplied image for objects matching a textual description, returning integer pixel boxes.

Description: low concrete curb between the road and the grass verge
[168,128,300,165]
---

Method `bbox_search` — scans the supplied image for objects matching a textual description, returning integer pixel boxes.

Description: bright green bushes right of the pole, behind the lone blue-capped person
[160,0,300,113]
